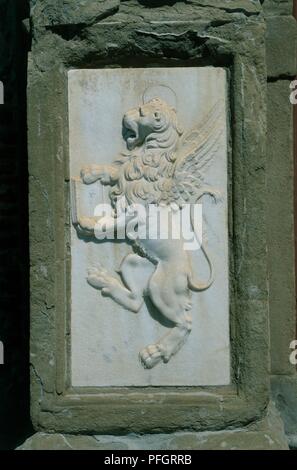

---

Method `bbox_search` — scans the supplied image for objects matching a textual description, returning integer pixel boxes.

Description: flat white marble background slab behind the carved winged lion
[68,67,230,387]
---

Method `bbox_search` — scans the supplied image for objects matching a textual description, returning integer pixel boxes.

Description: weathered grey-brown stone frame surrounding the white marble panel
[28,12,269,434]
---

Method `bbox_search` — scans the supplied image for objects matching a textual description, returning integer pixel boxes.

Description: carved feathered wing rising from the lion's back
[169,101,225,204]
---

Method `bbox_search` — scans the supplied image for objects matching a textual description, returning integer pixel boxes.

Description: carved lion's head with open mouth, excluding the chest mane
[123,98,182,150]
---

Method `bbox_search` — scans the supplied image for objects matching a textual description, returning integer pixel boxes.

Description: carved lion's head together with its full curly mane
[110,98,182,205]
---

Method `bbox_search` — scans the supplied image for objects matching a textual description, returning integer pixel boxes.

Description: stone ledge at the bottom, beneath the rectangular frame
[17,405,288,451]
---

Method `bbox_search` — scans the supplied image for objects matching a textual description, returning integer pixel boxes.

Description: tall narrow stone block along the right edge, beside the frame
[267,80,296,374]
